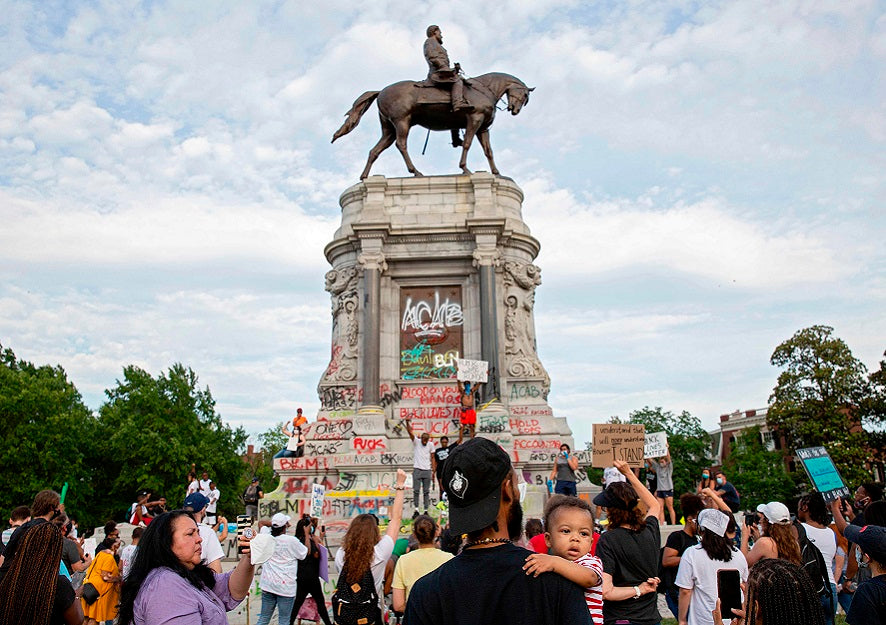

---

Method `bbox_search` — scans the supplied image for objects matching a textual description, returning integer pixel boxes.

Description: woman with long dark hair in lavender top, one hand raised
[118,510,255,625]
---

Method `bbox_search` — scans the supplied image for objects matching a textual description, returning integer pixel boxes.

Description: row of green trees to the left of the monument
[0,345,276,529]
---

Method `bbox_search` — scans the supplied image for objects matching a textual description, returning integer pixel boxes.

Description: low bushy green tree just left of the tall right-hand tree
[725,426,796,510]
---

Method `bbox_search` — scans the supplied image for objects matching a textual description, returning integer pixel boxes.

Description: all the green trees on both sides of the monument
[0,325,886,527]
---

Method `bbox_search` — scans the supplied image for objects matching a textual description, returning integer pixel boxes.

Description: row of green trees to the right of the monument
[588,325,886,509]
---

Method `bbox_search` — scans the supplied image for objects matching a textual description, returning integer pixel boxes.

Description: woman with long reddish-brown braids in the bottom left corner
[0,523,83,625]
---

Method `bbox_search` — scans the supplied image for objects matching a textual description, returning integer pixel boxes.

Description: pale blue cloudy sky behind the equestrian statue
[0,0,886,443]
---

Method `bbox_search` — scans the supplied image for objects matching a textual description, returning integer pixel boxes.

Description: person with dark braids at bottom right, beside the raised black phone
[713,558,824,625]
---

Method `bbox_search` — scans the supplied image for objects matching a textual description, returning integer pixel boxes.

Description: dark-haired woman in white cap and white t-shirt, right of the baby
[675,508,748,625]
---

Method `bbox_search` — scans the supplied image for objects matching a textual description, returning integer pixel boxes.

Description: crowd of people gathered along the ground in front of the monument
[0,442,886,625]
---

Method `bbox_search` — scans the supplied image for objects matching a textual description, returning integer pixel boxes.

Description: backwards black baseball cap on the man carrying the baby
[441,437,512,534]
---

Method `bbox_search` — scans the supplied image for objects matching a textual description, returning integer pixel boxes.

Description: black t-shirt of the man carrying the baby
[404,544,591,625]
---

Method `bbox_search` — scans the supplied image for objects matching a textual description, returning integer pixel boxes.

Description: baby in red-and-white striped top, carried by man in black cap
[523,495,603,625]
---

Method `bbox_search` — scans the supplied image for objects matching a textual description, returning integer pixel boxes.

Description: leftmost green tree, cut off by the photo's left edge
[0,345,96,524]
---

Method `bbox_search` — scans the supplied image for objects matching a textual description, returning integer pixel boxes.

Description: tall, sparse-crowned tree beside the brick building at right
[766,325,874,487]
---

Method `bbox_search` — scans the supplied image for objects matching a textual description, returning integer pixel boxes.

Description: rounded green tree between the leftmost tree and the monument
[96,364,246,519]
